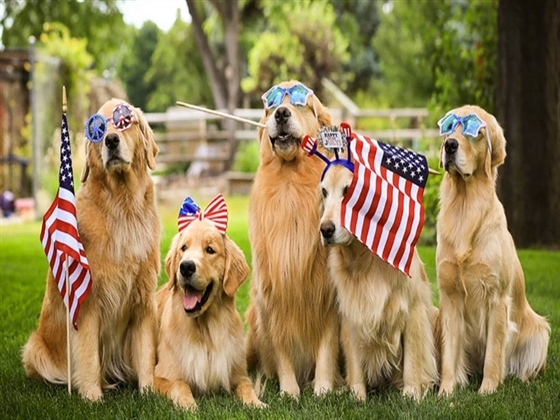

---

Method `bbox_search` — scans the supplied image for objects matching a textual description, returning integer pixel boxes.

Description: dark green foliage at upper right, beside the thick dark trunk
[374,0,497,112]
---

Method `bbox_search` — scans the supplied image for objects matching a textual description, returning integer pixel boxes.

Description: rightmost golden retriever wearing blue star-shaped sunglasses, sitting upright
[436,106,550,396]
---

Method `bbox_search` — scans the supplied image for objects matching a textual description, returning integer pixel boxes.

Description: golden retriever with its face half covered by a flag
[317,163,438,400]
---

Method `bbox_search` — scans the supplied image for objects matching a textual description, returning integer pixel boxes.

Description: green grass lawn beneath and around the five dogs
[0,197,560,419]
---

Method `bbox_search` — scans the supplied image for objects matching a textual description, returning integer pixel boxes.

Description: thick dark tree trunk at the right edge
[496,0,560,248]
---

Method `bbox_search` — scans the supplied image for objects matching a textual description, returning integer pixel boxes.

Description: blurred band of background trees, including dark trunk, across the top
[0,0,560,246]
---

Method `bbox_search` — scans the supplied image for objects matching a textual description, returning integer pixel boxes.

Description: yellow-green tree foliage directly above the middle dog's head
[243,0,349,101]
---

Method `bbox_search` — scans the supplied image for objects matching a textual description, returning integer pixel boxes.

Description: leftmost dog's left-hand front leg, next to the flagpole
[71,310,103,401]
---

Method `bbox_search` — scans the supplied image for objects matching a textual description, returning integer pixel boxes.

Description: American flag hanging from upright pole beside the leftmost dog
[41,114,91,329]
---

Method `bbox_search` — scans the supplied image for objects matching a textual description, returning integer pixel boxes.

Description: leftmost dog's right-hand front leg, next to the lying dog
[130,299,157,393]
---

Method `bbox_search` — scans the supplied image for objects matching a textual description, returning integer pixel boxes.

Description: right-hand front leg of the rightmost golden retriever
[478,296,510,394]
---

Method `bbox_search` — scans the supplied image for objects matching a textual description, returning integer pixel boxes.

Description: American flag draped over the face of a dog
[342,135,428,276]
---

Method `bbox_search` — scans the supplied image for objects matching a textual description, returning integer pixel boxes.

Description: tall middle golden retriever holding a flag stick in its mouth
[246,81,339,398]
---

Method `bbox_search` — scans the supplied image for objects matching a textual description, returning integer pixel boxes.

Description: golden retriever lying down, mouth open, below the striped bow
[155,220,266,410]
